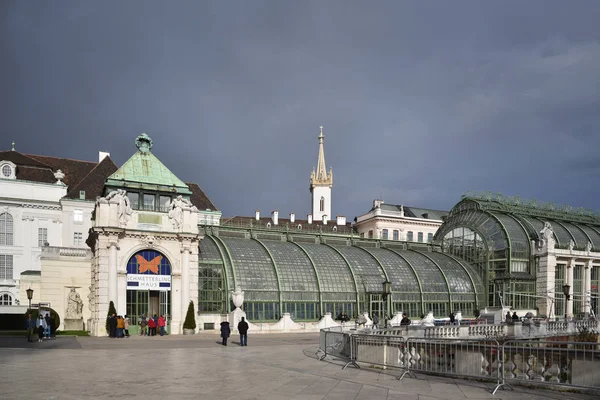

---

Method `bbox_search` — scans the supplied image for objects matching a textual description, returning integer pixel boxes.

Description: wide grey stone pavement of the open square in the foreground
[0,334,598,400]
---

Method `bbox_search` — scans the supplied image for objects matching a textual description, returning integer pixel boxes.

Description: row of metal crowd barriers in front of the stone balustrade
[318,329,600,394]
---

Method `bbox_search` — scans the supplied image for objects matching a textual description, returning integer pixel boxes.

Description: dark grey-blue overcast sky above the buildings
[0,0,600,218]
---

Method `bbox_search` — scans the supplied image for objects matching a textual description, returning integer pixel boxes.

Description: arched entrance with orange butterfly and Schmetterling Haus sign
[127,250,171,334]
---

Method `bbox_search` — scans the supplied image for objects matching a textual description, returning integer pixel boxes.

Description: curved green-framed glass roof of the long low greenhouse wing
[199,233,482,303]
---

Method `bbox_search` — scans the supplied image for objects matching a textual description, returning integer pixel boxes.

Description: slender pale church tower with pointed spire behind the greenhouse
[310,126,333,221]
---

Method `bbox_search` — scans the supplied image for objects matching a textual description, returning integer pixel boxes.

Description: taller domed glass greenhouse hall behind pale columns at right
[434,193,600,314]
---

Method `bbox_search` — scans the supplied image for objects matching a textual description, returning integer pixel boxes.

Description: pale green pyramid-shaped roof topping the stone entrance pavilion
[106,133,192,194]
